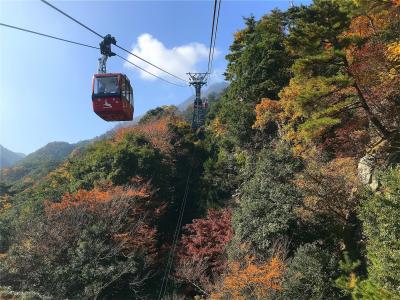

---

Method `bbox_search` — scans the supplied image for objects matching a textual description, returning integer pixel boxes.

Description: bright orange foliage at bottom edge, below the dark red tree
[211,254,285,300]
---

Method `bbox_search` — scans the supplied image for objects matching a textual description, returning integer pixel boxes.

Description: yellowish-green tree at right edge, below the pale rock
[360,167,400,293]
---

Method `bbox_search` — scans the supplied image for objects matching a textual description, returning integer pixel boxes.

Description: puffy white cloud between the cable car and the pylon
[124,33,218,80]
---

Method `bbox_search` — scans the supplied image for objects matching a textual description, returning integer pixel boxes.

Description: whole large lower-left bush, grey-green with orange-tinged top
[3,184,157,298]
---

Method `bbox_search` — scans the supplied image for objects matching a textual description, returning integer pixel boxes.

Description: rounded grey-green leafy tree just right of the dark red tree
[232,146,301,254]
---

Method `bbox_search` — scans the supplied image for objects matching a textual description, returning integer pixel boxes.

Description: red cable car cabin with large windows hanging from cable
[92,73,134,121]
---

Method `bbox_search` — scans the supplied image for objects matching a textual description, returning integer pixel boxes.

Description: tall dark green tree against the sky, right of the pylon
[216,10,292,146]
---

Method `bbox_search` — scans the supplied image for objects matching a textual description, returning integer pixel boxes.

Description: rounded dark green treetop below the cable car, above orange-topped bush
[68,132,166,190]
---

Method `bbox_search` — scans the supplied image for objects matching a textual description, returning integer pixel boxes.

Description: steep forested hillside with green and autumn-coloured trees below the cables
[0,0,400,300]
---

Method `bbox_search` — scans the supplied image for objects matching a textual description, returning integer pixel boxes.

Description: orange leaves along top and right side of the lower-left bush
[46,182,162,253]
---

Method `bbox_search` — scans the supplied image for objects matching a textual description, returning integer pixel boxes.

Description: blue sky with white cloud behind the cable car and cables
[0,0,310,154]
